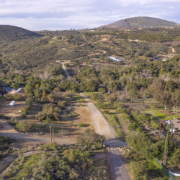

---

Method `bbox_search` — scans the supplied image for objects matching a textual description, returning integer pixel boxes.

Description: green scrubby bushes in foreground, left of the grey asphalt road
[3,130,109,180]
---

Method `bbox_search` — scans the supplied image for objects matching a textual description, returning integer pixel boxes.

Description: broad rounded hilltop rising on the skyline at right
[103,17,177,28]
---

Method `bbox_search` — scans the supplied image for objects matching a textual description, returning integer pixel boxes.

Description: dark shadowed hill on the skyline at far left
[0,25,42,42]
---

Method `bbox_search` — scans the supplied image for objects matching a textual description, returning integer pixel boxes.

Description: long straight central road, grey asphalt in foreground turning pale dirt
[87,103,129,180]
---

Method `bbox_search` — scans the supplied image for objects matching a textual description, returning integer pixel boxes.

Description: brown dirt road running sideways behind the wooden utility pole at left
[0,120,76,144]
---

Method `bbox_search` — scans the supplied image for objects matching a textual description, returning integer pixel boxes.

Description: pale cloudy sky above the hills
[0,0,180,30]
